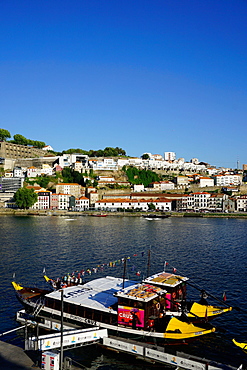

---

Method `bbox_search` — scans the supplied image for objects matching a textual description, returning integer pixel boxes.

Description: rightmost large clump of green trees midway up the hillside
[123,166,161,187]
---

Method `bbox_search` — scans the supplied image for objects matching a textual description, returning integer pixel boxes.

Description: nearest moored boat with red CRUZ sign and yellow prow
[12,276,215,341]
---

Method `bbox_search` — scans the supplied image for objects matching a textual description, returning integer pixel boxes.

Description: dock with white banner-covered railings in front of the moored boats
[0,311,245,370]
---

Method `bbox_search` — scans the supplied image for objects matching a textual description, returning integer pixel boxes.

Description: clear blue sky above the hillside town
[0,0,247,168]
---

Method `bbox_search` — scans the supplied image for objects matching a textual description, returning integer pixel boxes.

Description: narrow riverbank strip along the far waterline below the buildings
[0,208,247,219]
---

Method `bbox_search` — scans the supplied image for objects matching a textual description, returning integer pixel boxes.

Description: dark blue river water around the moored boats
[0,216,247,369]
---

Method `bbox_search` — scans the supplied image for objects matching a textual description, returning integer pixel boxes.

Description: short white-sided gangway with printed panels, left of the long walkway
[25,327,108,351]
